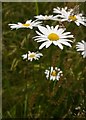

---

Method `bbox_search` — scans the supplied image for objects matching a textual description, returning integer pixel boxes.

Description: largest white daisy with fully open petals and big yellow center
[33,25,73,49]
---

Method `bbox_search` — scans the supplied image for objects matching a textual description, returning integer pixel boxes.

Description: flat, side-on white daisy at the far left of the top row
[8,20,41,29]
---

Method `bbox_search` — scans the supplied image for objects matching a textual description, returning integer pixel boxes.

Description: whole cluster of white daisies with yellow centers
[8,7,86,81]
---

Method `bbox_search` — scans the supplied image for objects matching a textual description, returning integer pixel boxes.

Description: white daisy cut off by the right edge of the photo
[76,40,86,58]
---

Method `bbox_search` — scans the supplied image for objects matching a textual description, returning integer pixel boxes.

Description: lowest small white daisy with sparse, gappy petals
[45,66,63,81]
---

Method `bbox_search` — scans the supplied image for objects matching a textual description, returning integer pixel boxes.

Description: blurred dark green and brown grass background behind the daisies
[2,2,86,120]
